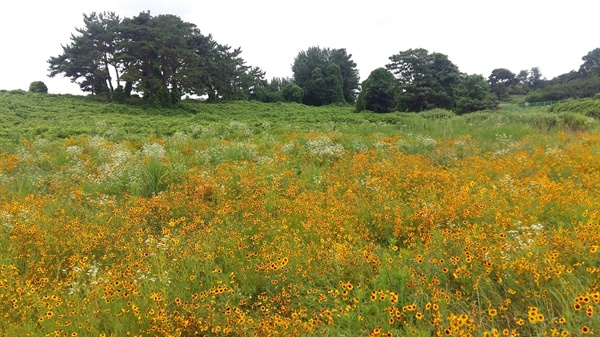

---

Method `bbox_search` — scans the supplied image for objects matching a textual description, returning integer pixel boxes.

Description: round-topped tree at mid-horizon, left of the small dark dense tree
[292,47,358,105]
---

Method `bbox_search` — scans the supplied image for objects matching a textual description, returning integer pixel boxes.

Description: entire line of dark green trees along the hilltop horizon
[48,12,600,114]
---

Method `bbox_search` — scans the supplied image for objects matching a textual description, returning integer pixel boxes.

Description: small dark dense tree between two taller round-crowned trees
[356,68,397,112]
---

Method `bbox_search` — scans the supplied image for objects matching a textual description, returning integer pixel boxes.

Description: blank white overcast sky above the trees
[0,0,600,94]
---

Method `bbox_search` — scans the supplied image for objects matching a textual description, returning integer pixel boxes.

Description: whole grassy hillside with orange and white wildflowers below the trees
[0,92,600,336]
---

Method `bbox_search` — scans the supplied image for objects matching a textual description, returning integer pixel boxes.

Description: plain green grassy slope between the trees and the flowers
[0,92,598,145]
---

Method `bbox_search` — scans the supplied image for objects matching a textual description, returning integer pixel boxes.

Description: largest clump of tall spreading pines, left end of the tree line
[48,12,265,106]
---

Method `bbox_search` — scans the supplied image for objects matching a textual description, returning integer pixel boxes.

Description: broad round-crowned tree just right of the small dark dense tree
[386,48,460,111]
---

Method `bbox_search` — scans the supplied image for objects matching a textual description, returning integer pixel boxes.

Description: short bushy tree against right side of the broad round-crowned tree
[453,74,497,115]
